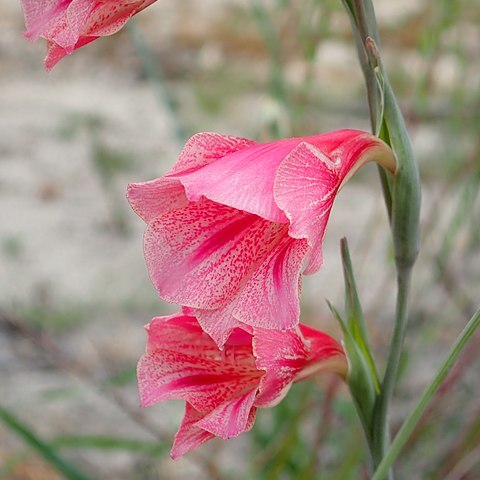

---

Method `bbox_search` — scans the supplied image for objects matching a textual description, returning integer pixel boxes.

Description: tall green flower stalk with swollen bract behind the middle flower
[343,0,420,478]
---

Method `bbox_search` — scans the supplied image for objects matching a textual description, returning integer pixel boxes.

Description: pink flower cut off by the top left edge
[21,0,155,70]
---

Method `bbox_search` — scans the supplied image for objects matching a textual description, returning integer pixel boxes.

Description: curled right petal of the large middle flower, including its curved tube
[274,130,396,274]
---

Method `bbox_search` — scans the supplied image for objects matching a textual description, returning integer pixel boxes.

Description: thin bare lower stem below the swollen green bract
[372,269,411,474]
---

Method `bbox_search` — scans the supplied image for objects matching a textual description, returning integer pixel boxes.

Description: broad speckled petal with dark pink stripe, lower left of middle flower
[145,200,287,309]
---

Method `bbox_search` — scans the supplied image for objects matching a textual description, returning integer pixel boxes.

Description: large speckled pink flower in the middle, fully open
[127,130,395,346]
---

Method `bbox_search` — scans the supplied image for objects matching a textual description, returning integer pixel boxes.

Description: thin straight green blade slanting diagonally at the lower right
[372,309,480,480]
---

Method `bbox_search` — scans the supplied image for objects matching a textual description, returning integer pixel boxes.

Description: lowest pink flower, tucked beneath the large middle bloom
[137,309,347,458]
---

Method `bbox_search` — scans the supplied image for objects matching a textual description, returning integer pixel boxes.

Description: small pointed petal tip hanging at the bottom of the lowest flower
[170,402,215,460]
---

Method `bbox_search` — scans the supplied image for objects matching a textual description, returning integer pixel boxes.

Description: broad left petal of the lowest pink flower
[137,314,263,413]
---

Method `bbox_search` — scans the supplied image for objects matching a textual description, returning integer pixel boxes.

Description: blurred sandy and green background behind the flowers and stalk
[0,0,480,480]
